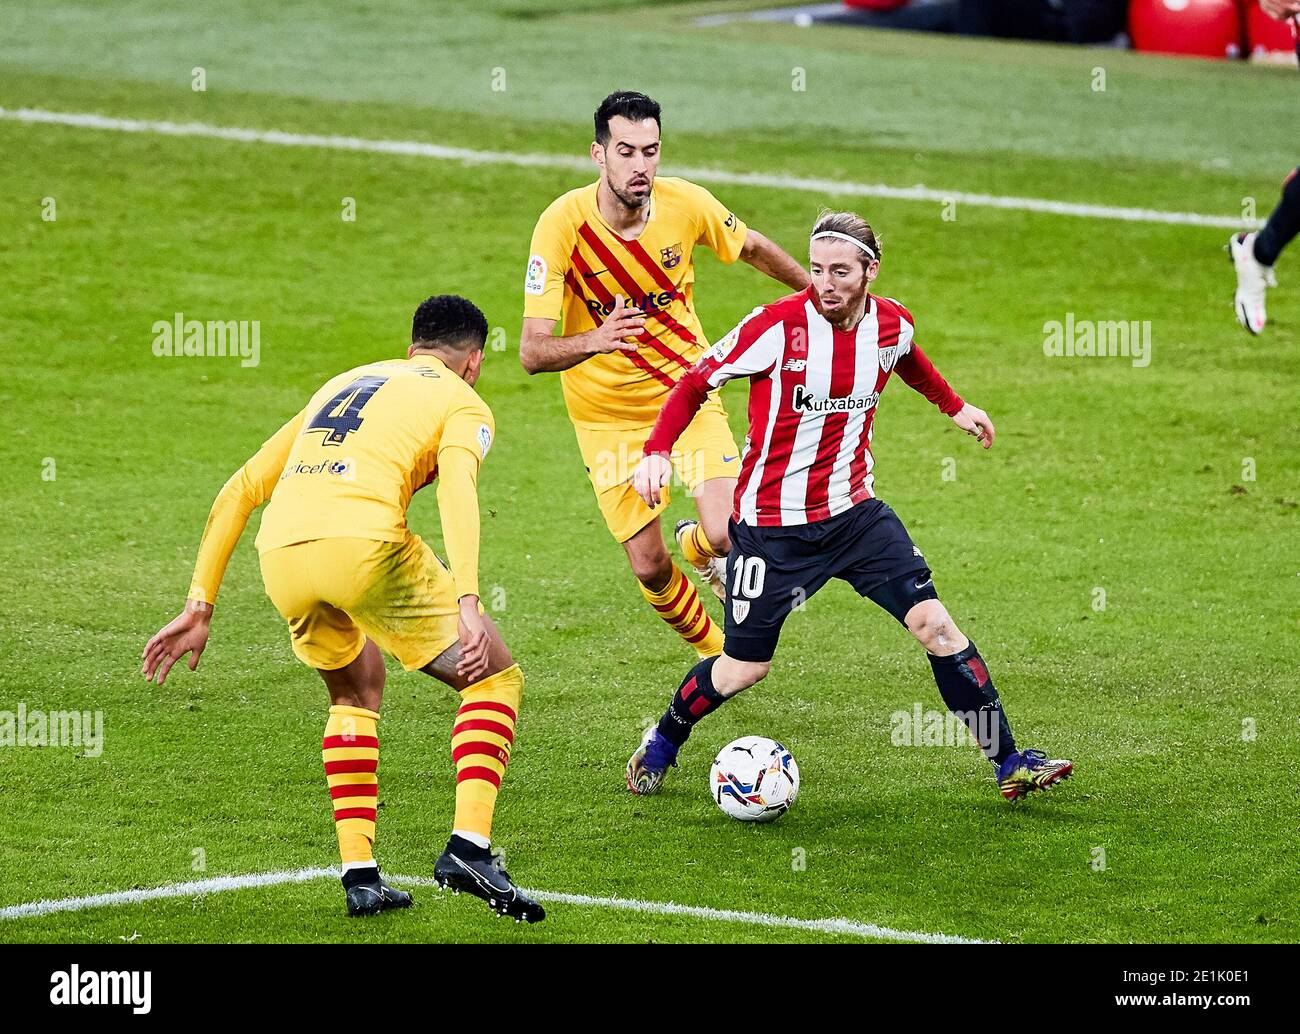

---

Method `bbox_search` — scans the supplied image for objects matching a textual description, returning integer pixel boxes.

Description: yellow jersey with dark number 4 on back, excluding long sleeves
[257,355,494,551]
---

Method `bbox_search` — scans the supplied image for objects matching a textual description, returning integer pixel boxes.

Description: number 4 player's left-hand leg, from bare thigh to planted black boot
[317,639,411,916]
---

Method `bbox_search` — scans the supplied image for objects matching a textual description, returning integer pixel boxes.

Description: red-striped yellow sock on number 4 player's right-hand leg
[451,665,524,842]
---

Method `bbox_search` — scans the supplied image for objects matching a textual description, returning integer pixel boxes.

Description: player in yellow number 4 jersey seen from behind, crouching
[143,295,545,922]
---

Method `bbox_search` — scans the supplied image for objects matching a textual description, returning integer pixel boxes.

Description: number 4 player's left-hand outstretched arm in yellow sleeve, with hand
[140,412,303,685]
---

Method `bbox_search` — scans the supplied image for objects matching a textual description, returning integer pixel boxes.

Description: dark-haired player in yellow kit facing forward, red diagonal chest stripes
[519,92,809,657]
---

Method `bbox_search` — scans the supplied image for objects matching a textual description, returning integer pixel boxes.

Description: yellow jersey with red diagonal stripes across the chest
[524,177,748,428]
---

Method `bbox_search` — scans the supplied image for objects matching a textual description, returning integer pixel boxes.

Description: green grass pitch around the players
[0,0,1300,943]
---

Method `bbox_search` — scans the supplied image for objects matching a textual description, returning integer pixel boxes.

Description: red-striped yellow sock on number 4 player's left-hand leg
[321,704,380,865]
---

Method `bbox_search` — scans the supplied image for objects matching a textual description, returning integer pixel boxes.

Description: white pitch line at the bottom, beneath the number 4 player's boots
[0,869,995,944]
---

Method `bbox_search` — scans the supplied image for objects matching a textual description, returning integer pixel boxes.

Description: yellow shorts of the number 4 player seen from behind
[261,533,460,671]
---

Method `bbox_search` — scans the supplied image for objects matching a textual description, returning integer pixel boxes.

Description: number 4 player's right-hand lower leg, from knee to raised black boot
[420,614,535,922]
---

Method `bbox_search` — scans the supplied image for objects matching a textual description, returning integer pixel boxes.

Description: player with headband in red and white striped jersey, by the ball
[627,212,1074,800]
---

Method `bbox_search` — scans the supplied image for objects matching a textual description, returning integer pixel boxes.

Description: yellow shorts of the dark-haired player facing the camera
[573,395,740,542]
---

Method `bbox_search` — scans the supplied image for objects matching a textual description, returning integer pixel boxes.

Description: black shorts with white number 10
[724,499,937,661]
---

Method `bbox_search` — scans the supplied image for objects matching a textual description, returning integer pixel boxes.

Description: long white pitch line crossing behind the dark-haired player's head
[0,108,1262,230]
